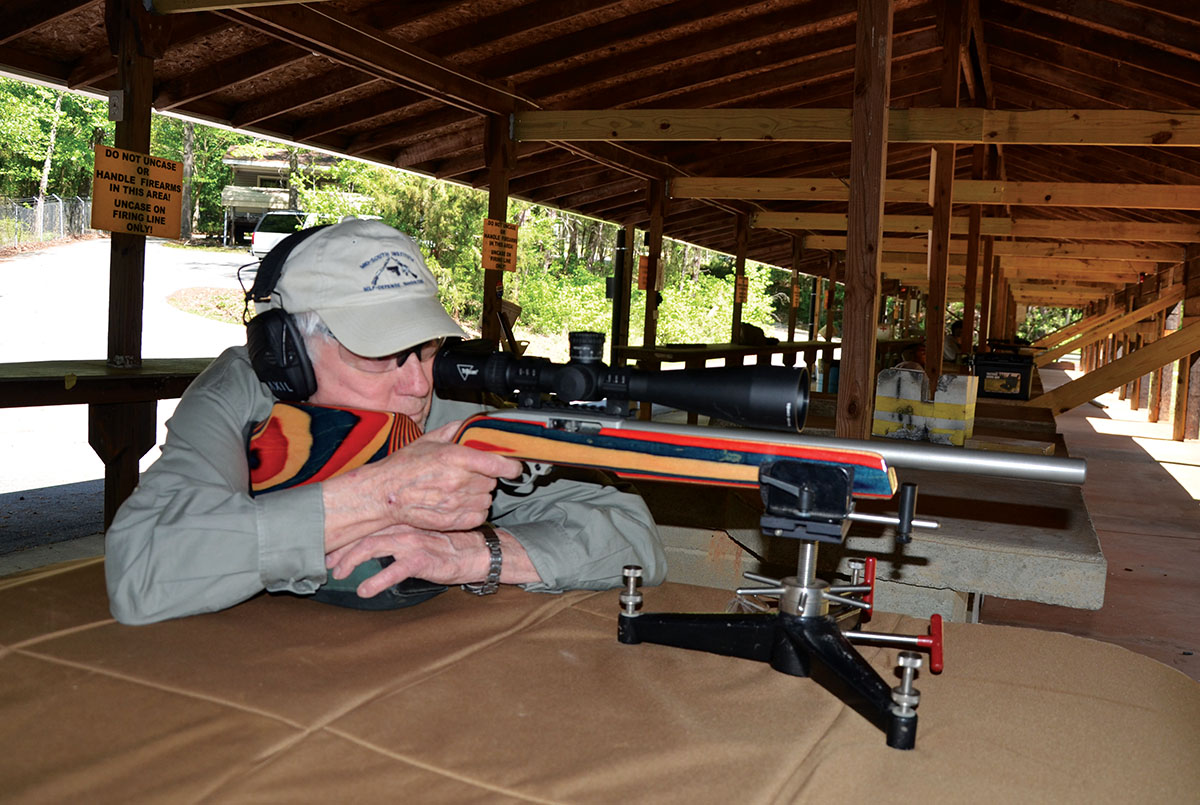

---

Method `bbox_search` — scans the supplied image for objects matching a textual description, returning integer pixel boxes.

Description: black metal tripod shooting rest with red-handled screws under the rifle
[617,461,942,750]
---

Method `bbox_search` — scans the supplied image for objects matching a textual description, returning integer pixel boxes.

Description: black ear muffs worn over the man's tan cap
[246,227,325,402]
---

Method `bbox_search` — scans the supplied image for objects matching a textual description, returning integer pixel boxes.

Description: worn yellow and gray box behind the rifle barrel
[871,370,979,447]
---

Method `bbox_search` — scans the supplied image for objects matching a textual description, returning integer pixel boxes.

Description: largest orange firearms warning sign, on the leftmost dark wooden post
[91,145,184,240]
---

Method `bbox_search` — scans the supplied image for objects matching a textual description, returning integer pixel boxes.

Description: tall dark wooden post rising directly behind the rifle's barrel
[836,0,895,439]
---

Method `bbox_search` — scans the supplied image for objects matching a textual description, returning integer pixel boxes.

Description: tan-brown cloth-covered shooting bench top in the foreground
[0,559,1200,805]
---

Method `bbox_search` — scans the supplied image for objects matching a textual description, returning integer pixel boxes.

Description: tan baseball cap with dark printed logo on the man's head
[271,220,466,358]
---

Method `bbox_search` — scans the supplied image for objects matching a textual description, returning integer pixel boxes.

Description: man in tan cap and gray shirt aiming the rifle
[106,221,666,624]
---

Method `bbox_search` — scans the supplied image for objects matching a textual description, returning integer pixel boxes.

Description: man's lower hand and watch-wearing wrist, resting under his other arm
[325,525,538,599]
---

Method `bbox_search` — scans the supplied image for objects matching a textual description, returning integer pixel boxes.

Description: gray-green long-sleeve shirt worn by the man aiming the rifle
[106,347,666,624]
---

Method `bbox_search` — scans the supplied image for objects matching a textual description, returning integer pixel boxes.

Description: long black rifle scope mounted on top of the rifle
[433,332,809,433]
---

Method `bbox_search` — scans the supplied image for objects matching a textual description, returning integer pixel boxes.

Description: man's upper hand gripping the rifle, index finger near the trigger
[323,422,522,554]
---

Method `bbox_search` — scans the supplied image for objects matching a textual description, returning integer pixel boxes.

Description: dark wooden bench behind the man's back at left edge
[0,358,212,528]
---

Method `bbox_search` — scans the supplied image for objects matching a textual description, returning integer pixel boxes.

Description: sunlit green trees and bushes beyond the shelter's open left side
[0,78,808,344]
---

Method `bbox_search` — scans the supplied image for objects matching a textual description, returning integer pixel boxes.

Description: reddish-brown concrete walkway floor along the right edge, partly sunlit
[980,370,1200,680]
